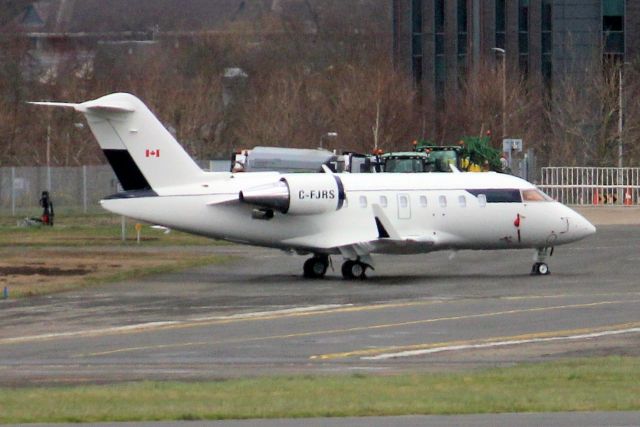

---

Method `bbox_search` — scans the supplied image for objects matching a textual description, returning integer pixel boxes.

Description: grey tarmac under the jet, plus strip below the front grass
[0,207,640,427]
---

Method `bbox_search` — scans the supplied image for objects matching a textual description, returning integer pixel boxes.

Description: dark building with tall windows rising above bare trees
[393,0,640,101]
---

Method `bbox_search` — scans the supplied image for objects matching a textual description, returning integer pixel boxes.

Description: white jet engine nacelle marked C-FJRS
[240,173,345,215]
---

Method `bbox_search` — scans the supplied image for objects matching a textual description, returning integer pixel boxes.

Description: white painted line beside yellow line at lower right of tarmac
[360,328,640,360]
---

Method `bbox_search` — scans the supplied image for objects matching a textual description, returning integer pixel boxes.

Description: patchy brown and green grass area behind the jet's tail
[0,214,235,298]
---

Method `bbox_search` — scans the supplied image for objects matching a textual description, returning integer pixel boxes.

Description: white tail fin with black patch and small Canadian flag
[32,93,204,191]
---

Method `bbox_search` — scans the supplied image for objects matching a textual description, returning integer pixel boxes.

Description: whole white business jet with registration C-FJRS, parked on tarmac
[34,93,595,279]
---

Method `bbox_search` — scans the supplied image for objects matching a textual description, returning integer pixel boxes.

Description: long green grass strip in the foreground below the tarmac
[0,357,640,423]
